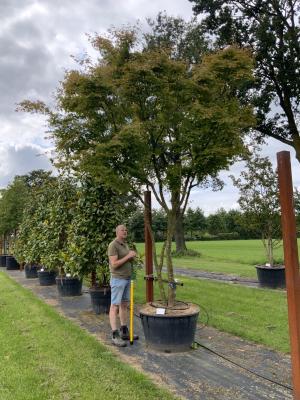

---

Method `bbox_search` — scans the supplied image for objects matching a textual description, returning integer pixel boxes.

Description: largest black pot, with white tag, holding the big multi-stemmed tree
[140,305,199,352]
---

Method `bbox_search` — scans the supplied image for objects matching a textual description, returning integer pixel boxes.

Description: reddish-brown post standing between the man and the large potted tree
[144,190,153,303]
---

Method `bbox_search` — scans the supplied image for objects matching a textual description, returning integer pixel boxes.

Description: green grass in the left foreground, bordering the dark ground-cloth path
[0,272,174,400]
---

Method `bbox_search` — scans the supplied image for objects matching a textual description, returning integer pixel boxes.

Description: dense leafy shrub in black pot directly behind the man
[65,176,126,314]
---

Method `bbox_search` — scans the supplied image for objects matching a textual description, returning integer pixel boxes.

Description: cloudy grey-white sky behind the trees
[0,0,300,214]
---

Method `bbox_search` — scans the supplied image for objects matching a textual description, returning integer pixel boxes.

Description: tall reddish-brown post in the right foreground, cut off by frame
[277,151,300,400]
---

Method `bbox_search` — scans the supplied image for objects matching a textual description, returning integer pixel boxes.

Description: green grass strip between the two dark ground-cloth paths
[136,272,290,352]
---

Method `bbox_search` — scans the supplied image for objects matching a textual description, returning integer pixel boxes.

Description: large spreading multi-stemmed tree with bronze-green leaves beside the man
[23,25,254,305]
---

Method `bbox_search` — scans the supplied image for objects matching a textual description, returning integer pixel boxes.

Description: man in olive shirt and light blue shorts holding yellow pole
[108,225,137,347]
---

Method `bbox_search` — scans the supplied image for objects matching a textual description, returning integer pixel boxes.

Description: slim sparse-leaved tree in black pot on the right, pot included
[232,154,285,288]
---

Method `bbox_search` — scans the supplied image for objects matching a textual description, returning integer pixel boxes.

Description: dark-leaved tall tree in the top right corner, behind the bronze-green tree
[190,0,300,162]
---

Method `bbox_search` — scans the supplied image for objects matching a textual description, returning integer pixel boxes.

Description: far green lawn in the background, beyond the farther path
[137,240,283,278]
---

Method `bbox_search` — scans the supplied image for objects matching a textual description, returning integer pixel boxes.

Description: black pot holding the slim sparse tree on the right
[256,265,285,289]
